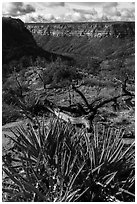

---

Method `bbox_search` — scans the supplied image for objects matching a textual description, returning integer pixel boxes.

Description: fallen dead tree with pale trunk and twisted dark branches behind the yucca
[15,76,135,129]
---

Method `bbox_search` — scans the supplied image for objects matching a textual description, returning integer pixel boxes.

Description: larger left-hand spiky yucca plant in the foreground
[3,120,84,201]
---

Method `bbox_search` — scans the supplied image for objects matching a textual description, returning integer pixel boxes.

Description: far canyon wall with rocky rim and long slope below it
[26,22,135,71]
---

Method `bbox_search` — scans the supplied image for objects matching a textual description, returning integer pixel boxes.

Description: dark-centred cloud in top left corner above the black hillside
[3,2,35,17]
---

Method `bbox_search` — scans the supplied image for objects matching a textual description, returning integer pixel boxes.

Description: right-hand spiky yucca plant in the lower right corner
[78,125,135,201]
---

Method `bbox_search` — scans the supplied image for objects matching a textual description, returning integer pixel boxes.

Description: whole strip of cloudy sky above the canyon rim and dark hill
[2,1,135,23]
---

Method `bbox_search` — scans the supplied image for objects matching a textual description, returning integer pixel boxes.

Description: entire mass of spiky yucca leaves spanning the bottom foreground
[3,119,134,202]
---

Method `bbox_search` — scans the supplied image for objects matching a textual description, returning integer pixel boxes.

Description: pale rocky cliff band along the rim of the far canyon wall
[26,22,135,38]
